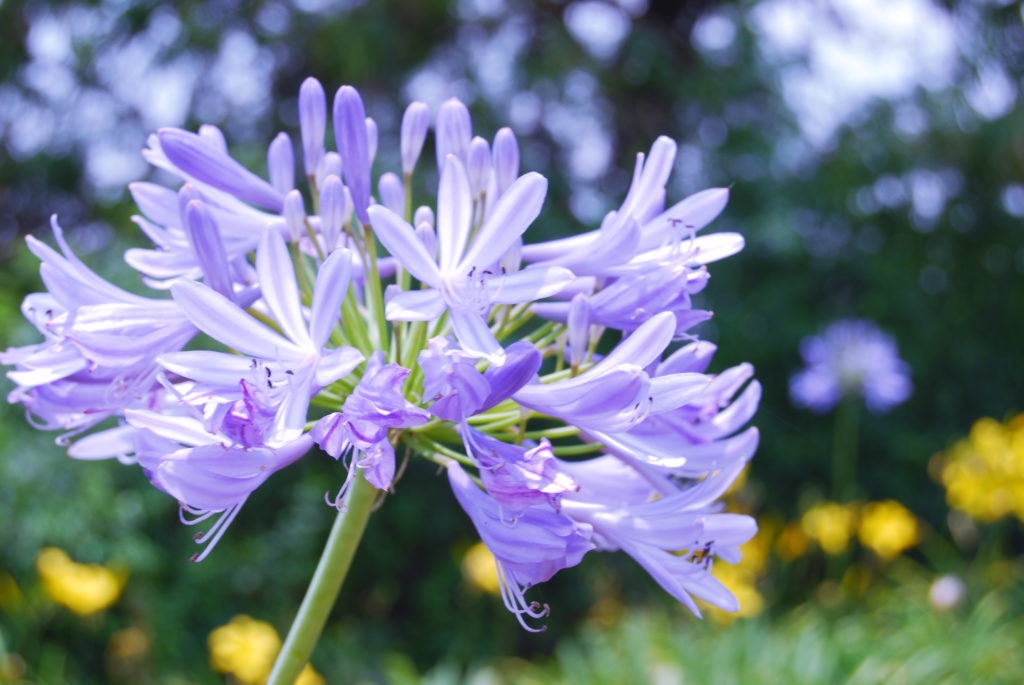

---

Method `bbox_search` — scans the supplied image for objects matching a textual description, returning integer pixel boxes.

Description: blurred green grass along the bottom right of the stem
[387,581,1024,685]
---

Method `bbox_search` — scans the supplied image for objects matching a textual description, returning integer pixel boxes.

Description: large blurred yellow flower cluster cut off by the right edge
[938,414,1024,521]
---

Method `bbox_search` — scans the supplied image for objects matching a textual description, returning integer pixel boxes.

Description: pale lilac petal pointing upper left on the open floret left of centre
[171,281,305,359]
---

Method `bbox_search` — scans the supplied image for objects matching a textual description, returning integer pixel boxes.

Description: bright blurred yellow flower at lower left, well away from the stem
[36,547,127,616]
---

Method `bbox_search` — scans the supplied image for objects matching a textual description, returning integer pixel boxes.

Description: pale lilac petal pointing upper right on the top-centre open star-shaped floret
[458,171,548,273]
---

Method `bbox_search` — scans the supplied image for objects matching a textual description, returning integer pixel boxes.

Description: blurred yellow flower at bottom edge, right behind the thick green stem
[207,614,324,685]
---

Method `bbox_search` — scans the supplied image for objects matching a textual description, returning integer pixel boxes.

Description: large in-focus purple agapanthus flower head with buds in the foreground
[0,79,761,630]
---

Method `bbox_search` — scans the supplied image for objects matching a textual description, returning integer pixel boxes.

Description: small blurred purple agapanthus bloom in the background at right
[790,318,911,413]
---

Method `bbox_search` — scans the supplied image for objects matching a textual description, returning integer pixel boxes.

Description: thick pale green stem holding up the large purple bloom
[266,471,377,685]
